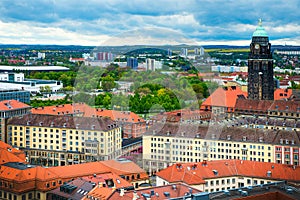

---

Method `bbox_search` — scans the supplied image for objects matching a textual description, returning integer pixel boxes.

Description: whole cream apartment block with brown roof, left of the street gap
[7,114,122,166]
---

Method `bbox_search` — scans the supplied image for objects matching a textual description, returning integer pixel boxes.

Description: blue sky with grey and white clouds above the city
[0,0,300,46]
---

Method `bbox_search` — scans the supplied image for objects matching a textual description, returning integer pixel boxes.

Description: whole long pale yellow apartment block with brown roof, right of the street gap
[143,123,300,173]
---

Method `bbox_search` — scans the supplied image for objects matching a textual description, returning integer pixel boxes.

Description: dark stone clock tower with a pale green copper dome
[248,19,274,100]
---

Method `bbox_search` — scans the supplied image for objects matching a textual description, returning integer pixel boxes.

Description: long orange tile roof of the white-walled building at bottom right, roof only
[156,160,300,185]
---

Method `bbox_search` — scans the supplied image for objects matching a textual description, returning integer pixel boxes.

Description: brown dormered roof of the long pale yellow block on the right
[144,122,300,145]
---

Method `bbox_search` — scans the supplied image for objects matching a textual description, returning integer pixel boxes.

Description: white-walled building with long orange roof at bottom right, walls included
[156,160,300,192]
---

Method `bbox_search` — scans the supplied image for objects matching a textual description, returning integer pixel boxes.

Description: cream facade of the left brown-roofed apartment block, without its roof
[8,125,122,165]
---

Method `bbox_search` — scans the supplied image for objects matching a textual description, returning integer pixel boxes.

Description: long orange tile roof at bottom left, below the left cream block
[0,162,148,193]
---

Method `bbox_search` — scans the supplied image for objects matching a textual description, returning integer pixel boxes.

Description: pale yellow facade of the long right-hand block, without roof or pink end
[143,135,275,173]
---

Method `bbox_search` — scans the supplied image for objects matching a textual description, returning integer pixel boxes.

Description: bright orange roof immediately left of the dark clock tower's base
[201,86,247,109]
